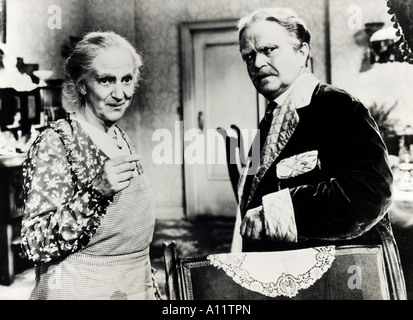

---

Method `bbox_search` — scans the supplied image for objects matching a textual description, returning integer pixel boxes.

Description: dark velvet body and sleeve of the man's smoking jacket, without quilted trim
[241,84,404,298]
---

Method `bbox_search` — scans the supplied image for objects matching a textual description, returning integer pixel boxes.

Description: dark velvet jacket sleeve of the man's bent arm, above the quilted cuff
[291,94,393,240]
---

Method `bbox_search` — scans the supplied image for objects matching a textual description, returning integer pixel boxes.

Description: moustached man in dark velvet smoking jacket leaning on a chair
[233,8,405,299]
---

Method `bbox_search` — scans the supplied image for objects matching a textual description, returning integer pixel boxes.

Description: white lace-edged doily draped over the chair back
[207,246,335,298]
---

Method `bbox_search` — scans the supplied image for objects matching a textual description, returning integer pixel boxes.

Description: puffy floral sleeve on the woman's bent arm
[22,130,111,264]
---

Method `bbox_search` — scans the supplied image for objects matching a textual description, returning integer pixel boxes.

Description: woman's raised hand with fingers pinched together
[92,154,142,198]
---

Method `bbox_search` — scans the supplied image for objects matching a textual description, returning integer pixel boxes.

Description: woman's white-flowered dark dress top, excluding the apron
[22,115,135,264]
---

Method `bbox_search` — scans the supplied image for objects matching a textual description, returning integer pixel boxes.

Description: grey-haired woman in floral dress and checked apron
[22,32,155,300]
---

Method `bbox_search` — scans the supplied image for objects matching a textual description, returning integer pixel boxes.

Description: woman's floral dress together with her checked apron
[22,115,155,300]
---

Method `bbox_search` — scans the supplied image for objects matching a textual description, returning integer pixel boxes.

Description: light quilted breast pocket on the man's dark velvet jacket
[277,150,318,179]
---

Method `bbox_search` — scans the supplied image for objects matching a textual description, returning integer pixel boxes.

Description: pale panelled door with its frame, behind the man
[181,21,263,218]
